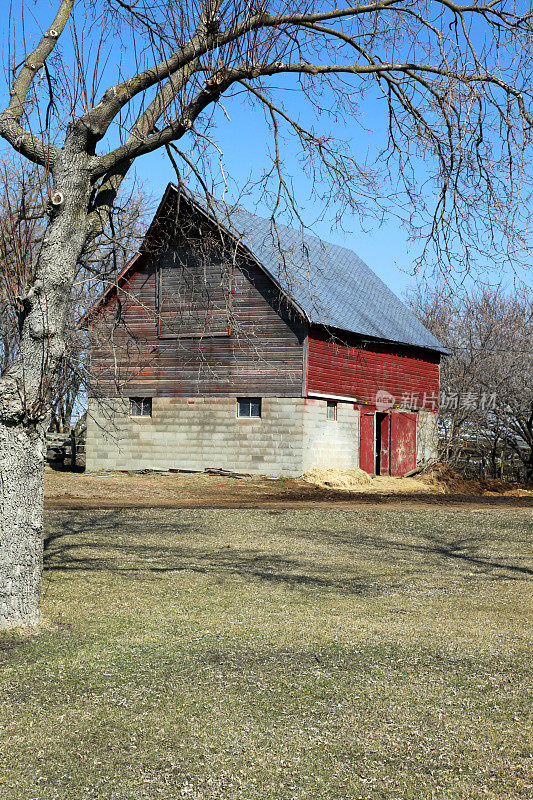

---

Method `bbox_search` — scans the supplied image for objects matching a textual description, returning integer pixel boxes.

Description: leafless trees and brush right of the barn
[408,285,533,481]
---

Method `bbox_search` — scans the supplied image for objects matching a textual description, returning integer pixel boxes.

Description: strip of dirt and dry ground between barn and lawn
[45,470,533,510]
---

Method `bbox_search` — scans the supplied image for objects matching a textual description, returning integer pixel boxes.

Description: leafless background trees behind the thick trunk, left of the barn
[0,159,149,432]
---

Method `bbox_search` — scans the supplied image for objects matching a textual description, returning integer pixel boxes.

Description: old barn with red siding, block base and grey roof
[84,184,445,477]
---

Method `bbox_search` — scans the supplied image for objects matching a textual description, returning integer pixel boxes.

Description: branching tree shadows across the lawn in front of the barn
[44,509,533,594]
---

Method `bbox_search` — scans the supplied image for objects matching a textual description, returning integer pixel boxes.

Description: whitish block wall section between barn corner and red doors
[303,398,359,472]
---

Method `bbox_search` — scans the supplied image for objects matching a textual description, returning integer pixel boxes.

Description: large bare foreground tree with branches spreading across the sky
[0,0,532,627]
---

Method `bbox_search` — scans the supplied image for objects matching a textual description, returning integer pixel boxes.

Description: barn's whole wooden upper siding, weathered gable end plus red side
[90,195,440,409]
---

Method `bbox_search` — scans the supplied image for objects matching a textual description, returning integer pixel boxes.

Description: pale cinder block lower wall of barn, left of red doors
[86,397,359,477]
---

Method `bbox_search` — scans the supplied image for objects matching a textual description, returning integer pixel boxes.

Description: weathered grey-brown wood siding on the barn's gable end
[87,220,306,397]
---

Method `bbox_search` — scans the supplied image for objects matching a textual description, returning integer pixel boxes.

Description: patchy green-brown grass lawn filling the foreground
[0,508,533,800]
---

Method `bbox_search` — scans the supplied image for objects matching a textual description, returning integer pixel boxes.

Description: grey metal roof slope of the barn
[186,188,447,353]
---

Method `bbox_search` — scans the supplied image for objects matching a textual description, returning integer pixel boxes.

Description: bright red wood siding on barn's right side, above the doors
[307,330,440,410]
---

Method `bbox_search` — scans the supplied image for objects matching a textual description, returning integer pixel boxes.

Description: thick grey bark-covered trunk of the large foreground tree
[0,134,91,629]
